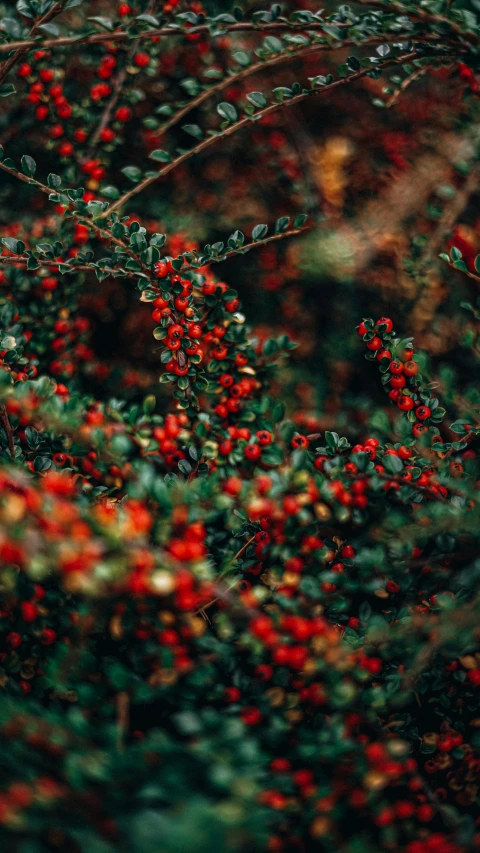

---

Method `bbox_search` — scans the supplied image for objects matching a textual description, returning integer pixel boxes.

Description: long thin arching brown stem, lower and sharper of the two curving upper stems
[104,51,428,216]
